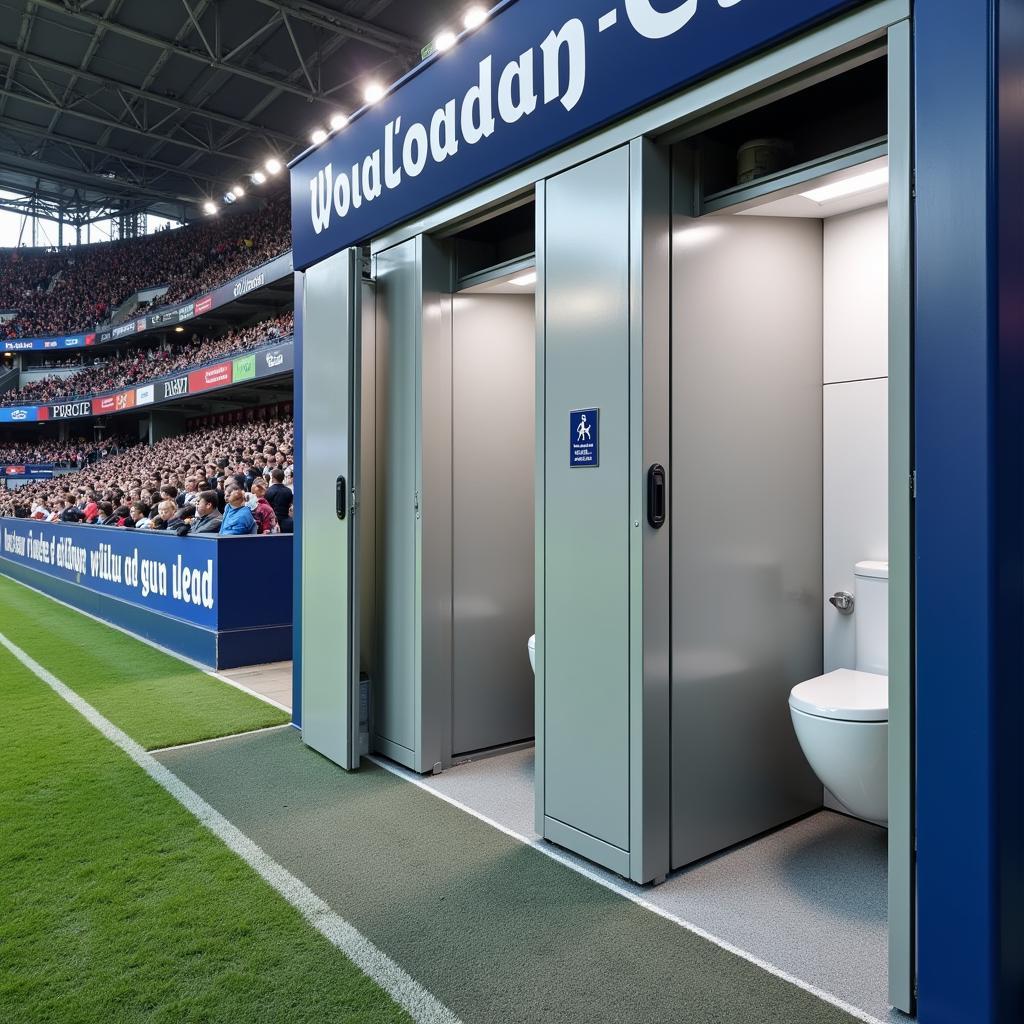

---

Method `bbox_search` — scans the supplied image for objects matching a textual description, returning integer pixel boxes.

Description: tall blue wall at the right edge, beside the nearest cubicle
[915,0,1024,1024]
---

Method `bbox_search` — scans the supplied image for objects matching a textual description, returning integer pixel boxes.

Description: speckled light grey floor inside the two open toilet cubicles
[411,750,908,1024]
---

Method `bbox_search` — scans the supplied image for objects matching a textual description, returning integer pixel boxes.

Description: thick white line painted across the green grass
[0,633,462,1024]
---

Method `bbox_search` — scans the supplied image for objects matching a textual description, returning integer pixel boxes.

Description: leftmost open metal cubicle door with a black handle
[297,249,361,769]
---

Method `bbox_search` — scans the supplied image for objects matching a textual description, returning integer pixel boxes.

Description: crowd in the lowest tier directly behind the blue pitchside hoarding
[0,418,295,537]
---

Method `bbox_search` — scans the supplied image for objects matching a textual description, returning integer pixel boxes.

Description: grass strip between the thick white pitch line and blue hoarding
[0,577,291,750]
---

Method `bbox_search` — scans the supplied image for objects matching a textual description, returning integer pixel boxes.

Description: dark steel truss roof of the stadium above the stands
[0,0,464,231]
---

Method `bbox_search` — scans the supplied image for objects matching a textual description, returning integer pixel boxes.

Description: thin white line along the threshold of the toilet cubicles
[368,754,886,1024]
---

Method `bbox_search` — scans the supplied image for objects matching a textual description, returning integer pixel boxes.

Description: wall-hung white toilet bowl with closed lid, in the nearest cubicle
[790,669,889,824]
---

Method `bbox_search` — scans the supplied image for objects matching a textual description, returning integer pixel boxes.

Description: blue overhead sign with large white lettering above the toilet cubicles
[292,0,858,269]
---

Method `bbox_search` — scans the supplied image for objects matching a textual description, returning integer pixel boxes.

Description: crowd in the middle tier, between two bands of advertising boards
[0,311,295,406]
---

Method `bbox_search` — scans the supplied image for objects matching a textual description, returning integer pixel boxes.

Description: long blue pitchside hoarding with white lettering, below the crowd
[0,518,292,668]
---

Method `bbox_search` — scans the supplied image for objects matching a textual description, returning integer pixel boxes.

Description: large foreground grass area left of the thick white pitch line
[0,647,409,1024]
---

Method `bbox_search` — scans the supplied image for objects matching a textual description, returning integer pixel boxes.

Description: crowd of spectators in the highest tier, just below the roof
[0,193,292,338]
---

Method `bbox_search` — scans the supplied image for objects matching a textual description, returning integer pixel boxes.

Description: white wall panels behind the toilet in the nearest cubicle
[822,206,889,672]
